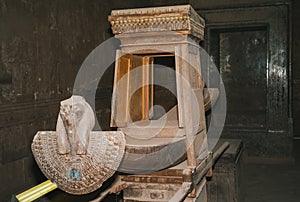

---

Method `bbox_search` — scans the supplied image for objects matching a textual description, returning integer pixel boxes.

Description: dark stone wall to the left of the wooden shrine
[0,0,148,201]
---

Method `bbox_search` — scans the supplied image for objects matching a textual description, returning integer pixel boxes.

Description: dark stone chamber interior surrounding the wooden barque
[0,0,300,202]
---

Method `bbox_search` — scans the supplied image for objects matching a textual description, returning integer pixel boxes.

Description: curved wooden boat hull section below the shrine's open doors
[118,136,186,174]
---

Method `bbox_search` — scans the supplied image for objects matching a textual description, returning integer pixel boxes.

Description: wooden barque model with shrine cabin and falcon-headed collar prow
[22,5,228,202]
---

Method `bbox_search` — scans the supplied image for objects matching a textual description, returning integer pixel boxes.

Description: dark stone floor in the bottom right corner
[244,165,300,202]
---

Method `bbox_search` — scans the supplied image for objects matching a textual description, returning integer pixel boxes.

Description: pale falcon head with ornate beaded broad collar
[31,96,125,195]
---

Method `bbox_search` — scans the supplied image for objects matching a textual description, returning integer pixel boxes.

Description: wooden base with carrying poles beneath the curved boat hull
[122,161,209,202]
